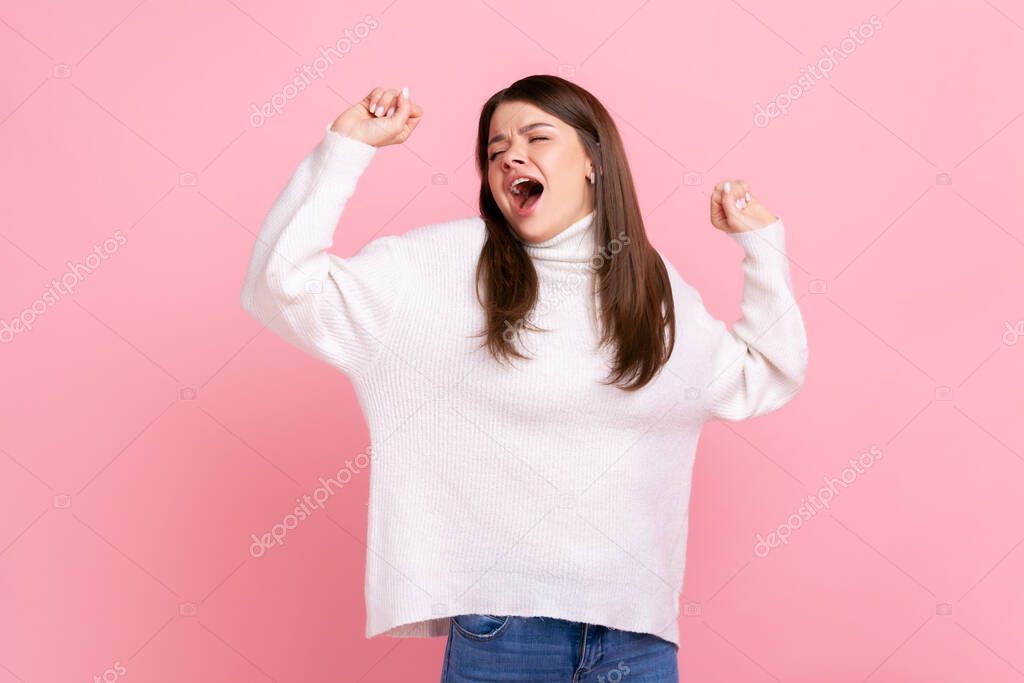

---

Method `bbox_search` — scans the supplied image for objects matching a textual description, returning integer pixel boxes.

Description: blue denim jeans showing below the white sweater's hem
[441,614,679,683]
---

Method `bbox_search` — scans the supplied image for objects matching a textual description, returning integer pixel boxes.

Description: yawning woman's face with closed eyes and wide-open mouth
[487,101,597,243]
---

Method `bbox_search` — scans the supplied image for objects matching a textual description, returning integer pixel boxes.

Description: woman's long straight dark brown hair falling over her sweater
[468,75,676,391]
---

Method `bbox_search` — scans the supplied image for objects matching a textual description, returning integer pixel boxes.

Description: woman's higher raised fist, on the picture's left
[331,88,423,147]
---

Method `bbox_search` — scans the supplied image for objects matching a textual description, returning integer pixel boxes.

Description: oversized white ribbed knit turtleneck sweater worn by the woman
[242,118,807,644]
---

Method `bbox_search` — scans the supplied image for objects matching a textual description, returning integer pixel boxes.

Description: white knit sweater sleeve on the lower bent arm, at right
[697,217,808,421]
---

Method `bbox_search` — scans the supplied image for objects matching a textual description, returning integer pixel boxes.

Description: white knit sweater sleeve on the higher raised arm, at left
[241,124,404,375]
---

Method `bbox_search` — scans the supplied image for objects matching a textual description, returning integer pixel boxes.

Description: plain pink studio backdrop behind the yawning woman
[0,0,1024,683]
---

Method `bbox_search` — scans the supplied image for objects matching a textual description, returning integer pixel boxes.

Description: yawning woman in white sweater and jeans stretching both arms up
[242,76,807,683]
